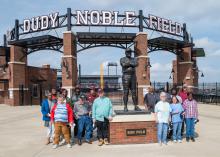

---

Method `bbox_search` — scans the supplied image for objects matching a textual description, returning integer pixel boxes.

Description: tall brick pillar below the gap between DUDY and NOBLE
[62,31,77,97]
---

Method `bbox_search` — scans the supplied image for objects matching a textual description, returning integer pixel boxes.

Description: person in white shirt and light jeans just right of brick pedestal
[154,92,172,146]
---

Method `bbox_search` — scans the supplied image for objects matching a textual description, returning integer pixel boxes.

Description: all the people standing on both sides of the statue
[41,83,198,148]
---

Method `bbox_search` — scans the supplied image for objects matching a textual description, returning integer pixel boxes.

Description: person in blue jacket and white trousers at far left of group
[41,93,54,145]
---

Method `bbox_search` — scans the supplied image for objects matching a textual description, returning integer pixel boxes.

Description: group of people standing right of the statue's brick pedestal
[144,85,199,145]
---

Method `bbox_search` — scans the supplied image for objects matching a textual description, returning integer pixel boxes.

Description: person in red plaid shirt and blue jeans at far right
[183,93,198,142]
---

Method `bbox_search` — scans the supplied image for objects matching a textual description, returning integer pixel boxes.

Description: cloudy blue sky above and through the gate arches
[0,0,220,82]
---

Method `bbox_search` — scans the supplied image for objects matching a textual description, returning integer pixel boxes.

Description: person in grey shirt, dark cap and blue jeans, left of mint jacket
[74,94,92,145]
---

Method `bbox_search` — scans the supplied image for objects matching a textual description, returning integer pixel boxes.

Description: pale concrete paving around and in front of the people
[0,104,220,157]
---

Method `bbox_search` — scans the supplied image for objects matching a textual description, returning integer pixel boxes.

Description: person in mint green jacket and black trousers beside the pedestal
[92,88,113,146]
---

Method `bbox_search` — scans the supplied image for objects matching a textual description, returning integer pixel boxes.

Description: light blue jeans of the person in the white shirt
[157,123,168,143]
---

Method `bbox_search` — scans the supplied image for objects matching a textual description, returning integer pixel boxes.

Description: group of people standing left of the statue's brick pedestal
[41,86,112,149]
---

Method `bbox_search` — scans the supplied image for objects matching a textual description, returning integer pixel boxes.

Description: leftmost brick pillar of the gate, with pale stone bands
[8,46,28,106]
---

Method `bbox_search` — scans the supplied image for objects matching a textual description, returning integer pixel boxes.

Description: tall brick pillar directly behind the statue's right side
[135,32,150,105]
